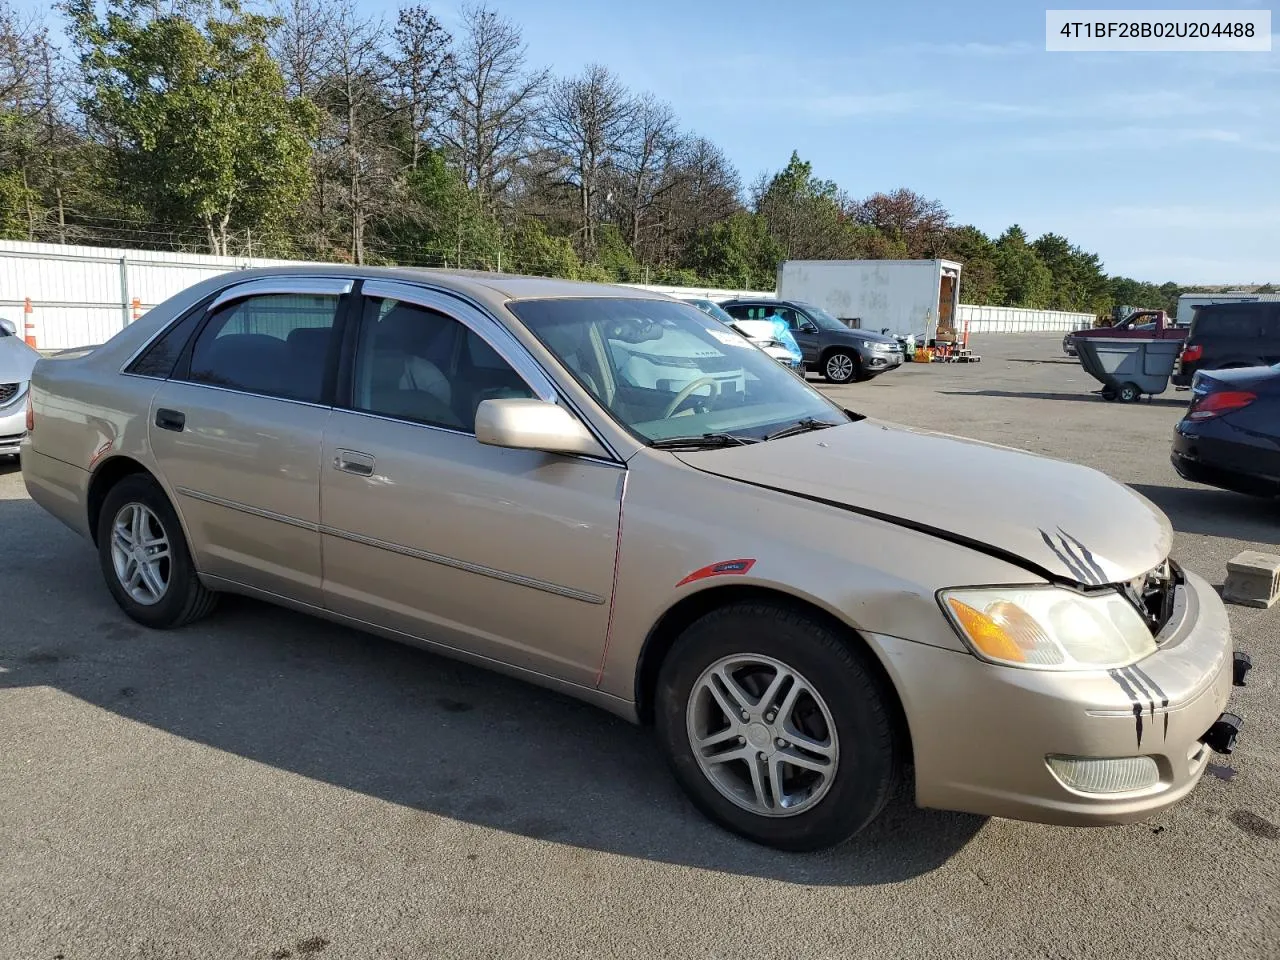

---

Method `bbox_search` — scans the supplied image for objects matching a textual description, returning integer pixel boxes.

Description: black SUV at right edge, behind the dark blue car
[1172,301,1280,387]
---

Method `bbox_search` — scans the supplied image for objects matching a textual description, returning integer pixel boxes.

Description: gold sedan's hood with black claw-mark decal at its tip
[678,420,1172,585]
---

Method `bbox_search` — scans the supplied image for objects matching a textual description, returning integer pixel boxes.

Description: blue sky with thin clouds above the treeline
[391,0,1280,284]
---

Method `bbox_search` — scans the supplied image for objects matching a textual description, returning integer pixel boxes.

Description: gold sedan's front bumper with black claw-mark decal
[872,573,1233,826]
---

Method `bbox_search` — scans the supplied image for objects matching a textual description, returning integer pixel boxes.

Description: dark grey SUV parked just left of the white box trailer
[721,300,902,383]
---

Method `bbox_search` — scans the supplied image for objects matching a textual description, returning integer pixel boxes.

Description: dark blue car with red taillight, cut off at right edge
[1170,364,1280,497]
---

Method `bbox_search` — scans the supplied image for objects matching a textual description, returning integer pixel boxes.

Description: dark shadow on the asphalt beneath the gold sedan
[0,499,986,886]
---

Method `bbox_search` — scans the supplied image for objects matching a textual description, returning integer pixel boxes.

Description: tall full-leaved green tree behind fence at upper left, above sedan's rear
[67,0,315,253]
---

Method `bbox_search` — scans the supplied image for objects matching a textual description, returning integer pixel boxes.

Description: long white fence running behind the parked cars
[0,241,1093,349]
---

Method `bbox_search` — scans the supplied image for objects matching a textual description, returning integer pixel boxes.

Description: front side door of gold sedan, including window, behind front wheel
[321,282,626,685]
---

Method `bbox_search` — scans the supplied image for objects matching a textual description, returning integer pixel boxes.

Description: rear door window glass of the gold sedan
[188,293,338,403]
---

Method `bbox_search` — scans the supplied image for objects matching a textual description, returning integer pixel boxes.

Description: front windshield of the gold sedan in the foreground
[508,297,849,443]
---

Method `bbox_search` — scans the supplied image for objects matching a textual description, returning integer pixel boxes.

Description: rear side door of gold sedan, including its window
[150,278,351,605]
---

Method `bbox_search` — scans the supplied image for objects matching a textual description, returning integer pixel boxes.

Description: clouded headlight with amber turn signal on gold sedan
[940,586,1156,671]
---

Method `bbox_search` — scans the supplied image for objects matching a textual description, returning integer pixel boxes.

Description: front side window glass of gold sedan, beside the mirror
[353,298,535,433]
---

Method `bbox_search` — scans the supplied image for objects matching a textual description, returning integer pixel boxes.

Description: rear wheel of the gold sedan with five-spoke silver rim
[97,474,218,630]
